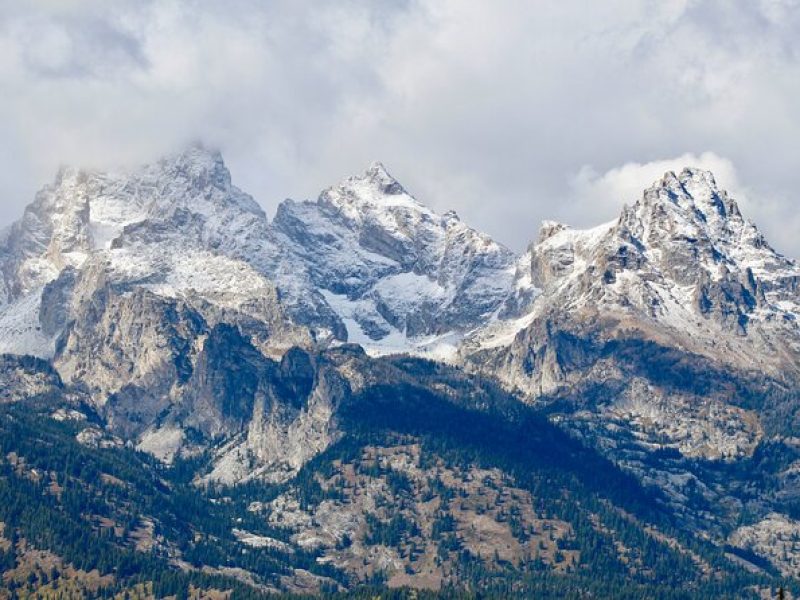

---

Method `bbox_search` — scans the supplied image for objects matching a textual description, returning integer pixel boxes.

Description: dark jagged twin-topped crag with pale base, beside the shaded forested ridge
[181,340,351,484]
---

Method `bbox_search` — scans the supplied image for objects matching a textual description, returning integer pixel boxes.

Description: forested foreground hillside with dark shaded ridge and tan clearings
[0,358,778,598]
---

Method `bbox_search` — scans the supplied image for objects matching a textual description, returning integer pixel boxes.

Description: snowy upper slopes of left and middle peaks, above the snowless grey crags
[0,146,514,357]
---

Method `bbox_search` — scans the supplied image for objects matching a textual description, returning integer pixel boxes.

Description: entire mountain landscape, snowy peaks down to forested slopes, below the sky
[0,145,800,599]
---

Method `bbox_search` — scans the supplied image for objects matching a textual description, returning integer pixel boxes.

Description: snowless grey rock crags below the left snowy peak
[55,287,341,474]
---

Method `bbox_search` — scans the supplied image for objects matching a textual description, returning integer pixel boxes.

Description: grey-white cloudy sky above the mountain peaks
[0,0,800,257]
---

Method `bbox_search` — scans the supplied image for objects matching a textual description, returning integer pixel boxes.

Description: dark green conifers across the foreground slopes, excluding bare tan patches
[0,353,798,600]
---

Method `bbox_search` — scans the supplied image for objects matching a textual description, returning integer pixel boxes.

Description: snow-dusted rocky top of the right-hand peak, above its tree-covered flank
[463,169,800,396]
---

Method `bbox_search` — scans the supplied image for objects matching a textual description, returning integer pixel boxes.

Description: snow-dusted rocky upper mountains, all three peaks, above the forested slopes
[0,146,800,468]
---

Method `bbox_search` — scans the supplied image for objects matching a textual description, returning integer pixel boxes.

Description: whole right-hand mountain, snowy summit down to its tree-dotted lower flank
[462,169,800,569]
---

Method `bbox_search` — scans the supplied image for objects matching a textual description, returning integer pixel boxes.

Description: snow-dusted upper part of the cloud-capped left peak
[0,146,308,358]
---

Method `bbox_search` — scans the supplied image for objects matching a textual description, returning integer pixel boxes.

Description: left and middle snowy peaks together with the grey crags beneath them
[0,146,514,481]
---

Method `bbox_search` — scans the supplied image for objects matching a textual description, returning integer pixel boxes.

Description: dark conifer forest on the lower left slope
[0,404,335,597]
